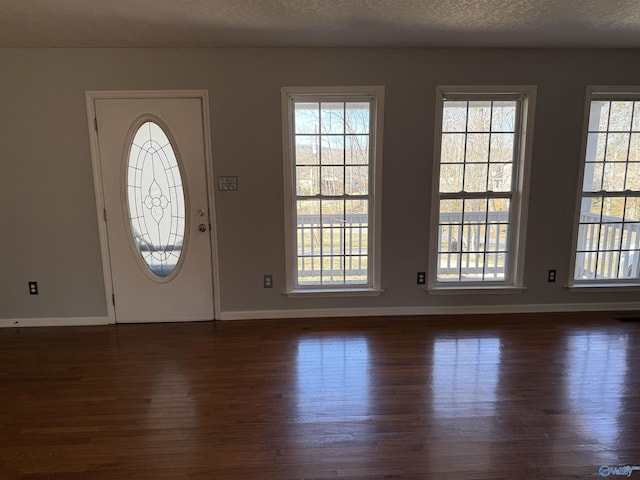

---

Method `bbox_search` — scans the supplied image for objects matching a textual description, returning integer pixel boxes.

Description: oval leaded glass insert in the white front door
[127,121,185,278]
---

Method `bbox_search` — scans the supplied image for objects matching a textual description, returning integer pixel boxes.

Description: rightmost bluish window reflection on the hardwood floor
[567,332,628,444]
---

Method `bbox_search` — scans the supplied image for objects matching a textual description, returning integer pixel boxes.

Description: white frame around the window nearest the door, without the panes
[281,86,384,296]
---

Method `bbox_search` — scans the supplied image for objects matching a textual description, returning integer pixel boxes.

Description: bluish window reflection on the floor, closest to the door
[296,337,370,422]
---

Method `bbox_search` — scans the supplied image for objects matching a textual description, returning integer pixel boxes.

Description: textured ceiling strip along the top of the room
[0,0,640,48]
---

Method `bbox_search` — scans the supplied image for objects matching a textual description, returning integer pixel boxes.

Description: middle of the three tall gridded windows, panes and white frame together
[430,87,535,288]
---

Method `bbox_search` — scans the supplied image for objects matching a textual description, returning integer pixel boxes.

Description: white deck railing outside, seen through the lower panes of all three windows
[297,212,640,280]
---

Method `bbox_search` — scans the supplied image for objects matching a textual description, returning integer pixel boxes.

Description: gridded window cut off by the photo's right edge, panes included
[574,91,640,284]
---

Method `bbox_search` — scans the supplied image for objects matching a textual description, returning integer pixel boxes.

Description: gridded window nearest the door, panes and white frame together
[283,87,383,292]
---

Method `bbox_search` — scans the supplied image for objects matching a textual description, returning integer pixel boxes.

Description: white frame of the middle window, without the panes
[427,85,537,294]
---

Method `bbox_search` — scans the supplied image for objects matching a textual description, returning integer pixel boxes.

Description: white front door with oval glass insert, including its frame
[89,94,214,323]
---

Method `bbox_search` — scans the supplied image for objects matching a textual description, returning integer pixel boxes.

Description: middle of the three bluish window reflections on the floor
[433,338,500,418]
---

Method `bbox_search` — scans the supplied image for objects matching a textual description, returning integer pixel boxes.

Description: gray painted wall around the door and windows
[0,49,640,318]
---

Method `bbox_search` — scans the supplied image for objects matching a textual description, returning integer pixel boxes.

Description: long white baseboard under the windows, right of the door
[218,302,640,320]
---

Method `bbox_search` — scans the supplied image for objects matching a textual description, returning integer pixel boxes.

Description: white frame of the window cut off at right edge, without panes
[568,85,640,291]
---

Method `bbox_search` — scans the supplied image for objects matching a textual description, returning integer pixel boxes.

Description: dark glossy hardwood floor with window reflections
[0,312,640,480]
